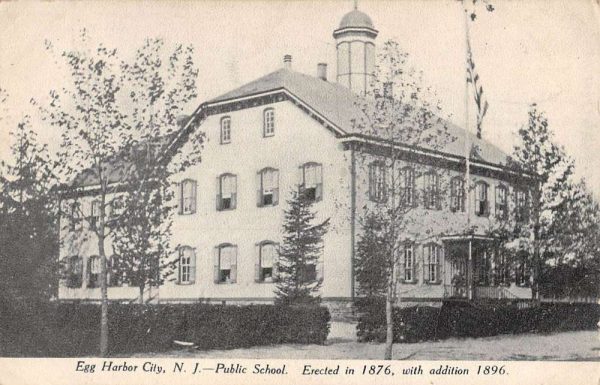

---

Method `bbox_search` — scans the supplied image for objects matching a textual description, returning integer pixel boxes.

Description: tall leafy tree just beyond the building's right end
[511,104,574,298]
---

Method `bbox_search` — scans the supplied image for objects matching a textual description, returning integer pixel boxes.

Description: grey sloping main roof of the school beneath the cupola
[206,68,509,165]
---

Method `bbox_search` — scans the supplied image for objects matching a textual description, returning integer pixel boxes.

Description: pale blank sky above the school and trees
[0,0,600,197]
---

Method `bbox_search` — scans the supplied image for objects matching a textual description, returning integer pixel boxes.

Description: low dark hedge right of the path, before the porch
[357,299,600,343]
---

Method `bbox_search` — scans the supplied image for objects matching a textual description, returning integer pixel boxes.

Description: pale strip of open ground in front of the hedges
[132,323,600,361]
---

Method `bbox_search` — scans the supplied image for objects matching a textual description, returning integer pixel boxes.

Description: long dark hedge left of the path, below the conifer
[0,296,330,357]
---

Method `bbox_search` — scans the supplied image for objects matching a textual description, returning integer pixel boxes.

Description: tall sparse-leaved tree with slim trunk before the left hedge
[42,31,201,356]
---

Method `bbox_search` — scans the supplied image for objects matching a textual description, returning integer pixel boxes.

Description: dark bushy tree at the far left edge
[0,116,58,302]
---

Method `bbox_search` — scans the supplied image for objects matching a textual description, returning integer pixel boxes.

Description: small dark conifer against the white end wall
[275,191,329,305]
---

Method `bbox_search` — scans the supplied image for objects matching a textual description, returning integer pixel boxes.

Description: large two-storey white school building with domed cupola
[59,9,531,305]
